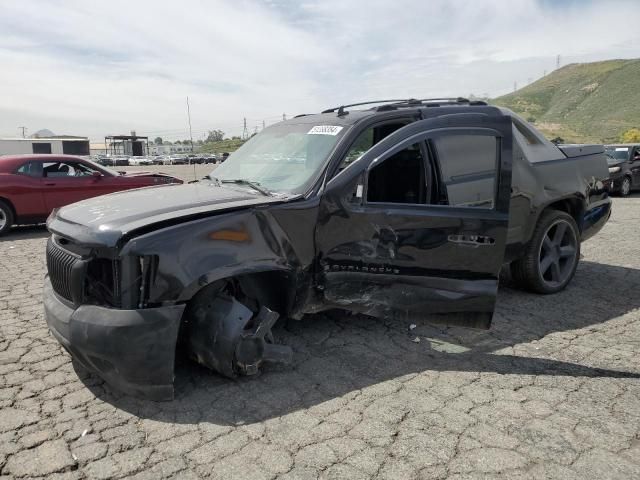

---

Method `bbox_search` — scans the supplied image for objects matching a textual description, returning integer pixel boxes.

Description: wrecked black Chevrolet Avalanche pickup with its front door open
[44,98,611,399]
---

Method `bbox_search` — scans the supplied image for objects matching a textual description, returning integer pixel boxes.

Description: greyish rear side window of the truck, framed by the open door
[433,135,498,209]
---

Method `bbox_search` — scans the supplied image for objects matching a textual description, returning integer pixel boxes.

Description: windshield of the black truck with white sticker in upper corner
[211,123,346,193]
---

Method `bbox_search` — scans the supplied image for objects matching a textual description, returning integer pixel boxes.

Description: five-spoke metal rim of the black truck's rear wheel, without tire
[538,220,578,287]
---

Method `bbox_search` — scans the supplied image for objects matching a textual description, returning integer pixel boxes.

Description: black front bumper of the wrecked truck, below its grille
[44,276,185,400]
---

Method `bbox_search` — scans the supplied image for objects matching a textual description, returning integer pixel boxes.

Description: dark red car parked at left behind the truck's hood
[0,155,182,235]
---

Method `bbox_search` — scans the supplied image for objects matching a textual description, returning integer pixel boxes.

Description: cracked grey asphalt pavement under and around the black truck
[0,177,640,480]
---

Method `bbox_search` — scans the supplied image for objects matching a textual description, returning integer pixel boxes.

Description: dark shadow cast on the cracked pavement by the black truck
[76,262,640,425]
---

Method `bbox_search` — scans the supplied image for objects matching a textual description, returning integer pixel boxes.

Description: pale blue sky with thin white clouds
[0,0,640,139]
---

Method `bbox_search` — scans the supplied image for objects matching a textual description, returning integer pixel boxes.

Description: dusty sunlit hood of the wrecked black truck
[47,182,298,247]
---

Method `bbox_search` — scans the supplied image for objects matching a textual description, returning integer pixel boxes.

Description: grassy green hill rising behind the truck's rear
[491,59,640,143]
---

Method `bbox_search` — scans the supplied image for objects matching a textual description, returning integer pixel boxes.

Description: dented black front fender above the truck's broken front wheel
[121,209,301,304]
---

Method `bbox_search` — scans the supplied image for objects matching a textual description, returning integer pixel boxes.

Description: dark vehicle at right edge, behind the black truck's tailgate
[605,143,640,197]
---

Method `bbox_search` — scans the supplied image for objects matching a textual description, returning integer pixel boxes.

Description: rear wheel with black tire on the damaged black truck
[511,210,580,294]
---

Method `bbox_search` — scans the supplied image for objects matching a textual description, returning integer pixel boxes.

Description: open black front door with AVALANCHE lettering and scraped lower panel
[316,114,512,328]
